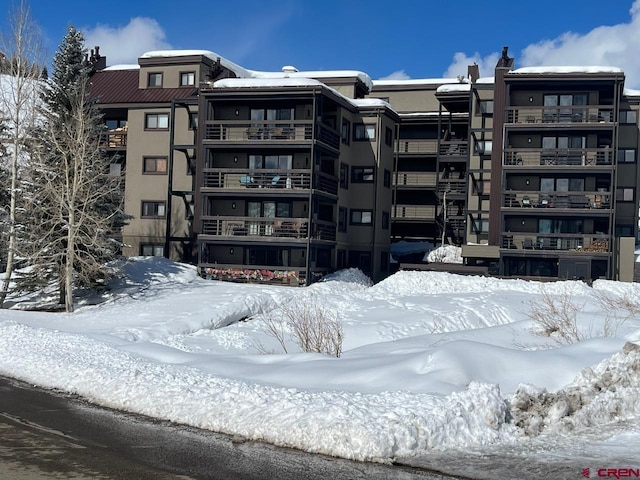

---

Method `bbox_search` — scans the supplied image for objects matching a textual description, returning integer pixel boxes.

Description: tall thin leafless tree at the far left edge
[0,0,44,308]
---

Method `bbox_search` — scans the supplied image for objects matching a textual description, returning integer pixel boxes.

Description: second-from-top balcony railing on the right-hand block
[503,148,614,167]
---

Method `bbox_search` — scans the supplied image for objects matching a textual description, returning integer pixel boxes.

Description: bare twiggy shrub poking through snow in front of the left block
[258,297,344,357]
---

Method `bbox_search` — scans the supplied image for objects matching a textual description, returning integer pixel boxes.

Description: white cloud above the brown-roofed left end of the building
[83,17,172,65]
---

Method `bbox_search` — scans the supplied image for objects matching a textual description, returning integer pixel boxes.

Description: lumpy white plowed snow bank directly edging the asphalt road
[0,322,507,462]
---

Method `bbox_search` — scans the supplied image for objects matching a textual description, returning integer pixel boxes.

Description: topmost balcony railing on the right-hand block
[505,105,613,124]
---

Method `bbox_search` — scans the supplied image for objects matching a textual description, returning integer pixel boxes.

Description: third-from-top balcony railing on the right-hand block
[502,191,611,210]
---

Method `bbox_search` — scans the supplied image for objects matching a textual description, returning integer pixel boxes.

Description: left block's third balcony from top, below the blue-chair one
[199,215,336,241]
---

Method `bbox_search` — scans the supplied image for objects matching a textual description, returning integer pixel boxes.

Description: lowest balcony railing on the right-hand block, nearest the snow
[502,232,610,253]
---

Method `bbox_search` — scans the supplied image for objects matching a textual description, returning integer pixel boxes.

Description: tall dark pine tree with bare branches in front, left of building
[21,27,123,312]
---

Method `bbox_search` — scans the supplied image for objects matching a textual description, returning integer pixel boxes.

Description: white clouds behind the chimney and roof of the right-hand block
[444,0,640,88]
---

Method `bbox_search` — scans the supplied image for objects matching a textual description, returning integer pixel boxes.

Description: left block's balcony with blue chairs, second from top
[202,168,338,195]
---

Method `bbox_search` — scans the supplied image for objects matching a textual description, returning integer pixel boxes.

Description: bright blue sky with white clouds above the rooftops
[7,0,640,88]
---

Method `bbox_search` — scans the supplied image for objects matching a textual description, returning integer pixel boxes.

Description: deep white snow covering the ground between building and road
[0,258,640,478]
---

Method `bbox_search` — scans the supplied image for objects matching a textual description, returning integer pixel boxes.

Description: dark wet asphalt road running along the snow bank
[0,377,454,480]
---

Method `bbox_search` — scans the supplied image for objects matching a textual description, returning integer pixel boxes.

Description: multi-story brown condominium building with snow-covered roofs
[86,44,640,285]
